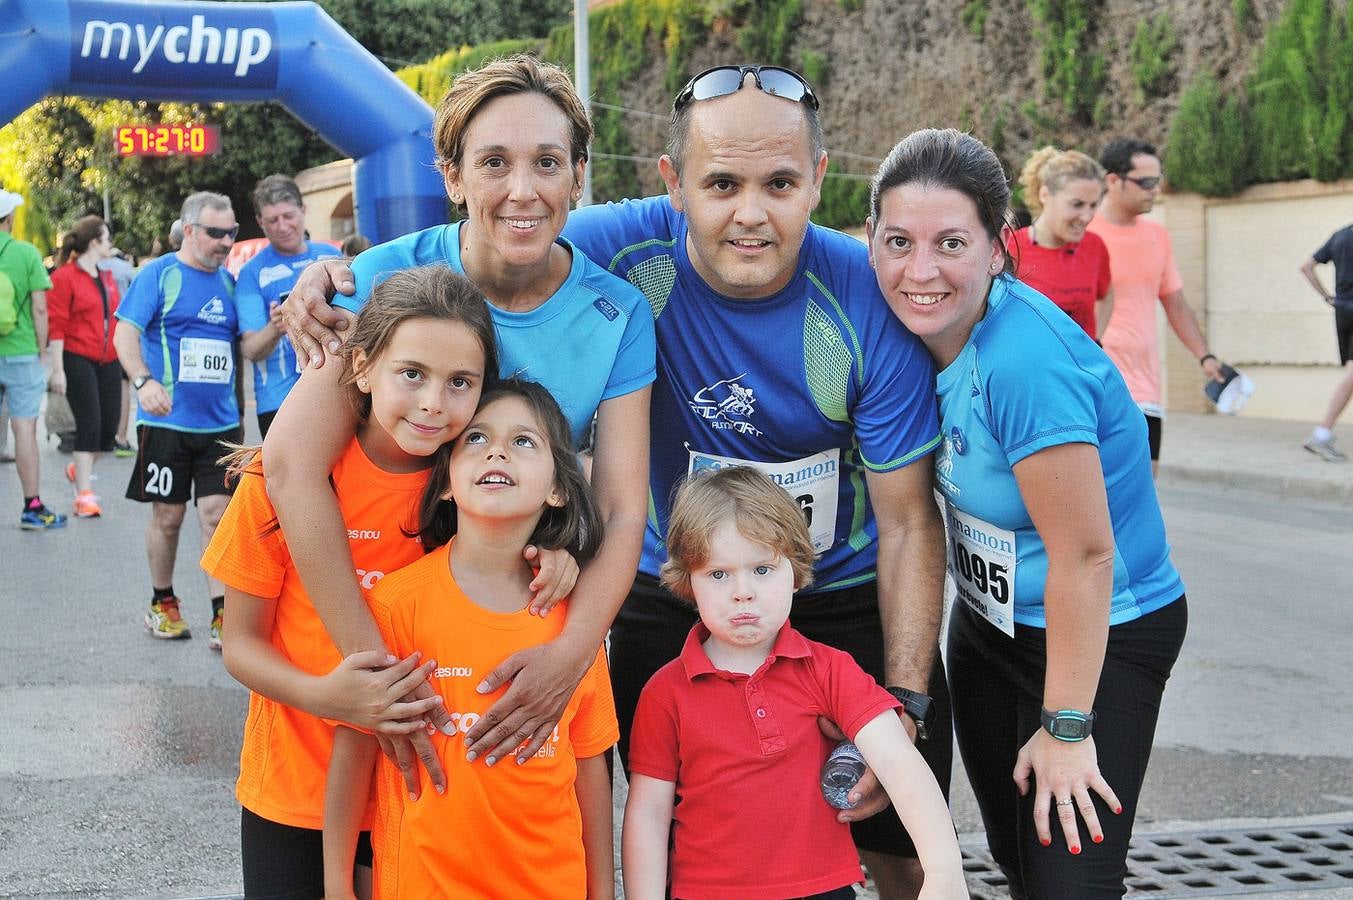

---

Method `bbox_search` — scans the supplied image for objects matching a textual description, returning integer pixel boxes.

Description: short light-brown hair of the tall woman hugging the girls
[432,53,593,171]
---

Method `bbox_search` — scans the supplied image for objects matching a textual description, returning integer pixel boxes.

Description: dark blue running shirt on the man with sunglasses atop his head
[564,198,939,591]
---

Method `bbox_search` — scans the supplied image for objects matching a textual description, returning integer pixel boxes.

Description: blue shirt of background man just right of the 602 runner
[235,241,341,414]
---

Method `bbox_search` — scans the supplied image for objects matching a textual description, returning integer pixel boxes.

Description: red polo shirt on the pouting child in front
[629,623,900,900]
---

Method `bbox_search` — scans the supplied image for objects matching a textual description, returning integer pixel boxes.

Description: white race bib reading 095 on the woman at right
[946,503,1015,637]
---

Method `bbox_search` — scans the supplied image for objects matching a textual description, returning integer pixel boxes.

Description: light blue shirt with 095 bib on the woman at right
[935,276,1184,628]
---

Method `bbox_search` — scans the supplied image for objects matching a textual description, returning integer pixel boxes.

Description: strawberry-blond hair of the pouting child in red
[659,466,817,601]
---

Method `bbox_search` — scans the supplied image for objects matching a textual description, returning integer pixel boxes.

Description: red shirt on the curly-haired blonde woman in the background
[1007,227,1111,338]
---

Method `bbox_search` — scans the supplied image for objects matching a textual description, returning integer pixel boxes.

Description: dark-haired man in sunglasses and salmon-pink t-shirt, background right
[1089,139,1226,474]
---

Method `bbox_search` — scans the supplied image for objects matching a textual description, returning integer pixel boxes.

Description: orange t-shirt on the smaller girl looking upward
[371,544,620,900]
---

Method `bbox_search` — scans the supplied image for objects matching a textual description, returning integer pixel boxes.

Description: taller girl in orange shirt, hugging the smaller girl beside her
[203,267,571,897]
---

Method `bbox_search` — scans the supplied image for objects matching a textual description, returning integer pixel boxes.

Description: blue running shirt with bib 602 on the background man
[116,253,239,432]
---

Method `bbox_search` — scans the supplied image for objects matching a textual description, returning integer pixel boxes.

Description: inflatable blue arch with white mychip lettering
[0,0,446,241]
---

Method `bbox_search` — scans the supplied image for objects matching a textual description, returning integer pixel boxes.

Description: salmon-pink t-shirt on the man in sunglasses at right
[1089,214,1184,415]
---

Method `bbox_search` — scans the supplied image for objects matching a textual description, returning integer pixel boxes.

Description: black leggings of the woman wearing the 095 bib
[946,594,1188,900]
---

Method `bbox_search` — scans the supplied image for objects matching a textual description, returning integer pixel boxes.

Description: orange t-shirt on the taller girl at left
[202,438,428,828]
